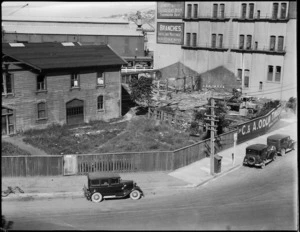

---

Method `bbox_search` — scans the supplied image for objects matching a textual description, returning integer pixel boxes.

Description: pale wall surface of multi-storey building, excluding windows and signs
[154,1,297,100]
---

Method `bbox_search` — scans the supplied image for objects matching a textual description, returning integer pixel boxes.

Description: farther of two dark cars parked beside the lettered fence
[267,134,296,156]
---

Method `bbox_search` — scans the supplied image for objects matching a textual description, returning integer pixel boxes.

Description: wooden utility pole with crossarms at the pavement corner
[205,97,219,176]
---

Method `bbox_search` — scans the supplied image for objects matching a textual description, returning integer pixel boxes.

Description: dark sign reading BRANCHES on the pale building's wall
[157,22,184,45]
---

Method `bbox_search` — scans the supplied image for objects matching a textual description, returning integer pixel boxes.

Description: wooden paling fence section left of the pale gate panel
[1,155,63,177]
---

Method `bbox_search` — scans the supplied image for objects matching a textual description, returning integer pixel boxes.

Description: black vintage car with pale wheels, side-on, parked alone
[83,172,144,203]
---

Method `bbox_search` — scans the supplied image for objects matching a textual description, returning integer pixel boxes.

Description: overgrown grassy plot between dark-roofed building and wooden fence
[2,116,195,155]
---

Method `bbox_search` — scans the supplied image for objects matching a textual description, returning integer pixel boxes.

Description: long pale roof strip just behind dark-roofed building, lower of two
[2,23,143,36]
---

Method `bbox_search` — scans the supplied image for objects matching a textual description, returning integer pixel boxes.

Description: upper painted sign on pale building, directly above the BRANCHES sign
[157,2,184,19]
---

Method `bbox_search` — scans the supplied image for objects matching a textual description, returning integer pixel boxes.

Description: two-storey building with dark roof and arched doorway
[1,43,126,134]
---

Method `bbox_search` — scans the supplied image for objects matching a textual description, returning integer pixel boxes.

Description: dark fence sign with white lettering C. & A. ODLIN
[237,106,282,143]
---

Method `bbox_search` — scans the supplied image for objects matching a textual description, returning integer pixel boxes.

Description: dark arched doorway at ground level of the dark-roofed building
[66,99,84,125]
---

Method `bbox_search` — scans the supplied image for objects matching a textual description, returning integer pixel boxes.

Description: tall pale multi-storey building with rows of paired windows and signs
[154,1,297,100]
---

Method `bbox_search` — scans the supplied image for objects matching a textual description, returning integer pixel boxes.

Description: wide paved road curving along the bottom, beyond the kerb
[2,151,299,230]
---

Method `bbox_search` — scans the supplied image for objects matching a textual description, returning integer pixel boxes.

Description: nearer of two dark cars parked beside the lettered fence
[243,144,277,168]
